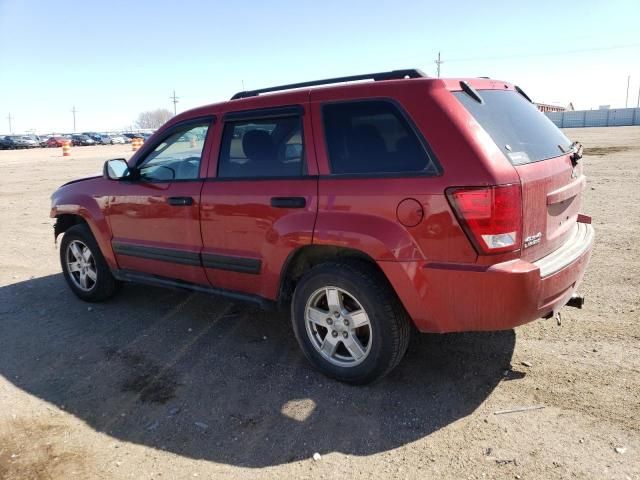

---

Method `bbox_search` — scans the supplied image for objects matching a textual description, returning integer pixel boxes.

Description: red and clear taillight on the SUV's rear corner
[447,184,522,254]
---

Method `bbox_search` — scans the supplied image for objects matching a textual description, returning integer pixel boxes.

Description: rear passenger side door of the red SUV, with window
[201,102,318,298]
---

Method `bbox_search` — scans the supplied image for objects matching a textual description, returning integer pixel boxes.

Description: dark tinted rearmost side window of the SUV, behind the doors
[322,100,438,175]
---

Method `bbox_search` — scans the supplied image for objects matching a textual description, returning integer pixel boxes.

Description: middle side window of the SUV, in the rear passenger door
[218,116,304,178]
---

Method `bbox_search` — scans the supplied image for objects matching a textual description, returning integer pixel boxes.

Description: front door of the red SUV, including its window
[108,119,211,285]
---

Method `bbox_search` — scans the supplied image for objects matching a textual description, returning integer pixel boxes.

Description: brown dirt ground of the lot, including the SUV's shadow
[0,127,640,479]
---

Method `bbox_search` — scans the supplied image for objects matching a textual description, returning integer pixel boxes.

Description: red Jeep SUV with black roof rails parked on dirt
[51,70,594,383]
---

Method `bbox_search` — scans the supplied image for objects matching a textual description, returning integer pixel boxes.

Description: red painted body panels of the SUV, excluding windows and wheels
[51,75,590,332]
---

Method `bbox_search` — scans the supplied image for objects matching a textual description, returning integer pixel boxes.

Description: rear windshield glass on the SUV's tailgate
[453,90,571,165]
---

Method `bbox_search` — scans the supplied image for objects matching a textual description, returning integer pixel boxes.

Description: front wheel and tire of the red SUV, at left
[60,224,118,302]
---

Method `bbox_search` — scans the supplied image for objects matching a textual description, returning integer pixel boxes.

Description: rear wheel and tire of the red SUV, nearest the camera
[292,262,411,384]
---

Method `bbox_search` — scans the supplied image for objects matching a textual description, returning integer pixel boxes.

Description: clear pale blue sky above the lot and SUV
[0,0,640,133]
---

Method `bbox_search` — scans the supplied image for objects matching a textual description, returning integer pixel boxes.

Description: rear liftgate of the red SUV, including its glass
[454,90,585,260]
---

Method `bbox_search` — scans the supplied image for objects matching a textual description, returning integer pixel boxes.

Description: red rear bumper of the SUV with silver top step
[378,223,594,332]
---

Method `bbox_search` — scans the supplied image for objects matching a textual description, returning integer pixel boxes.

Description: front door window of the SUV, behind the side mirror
[138,121,209,182]
